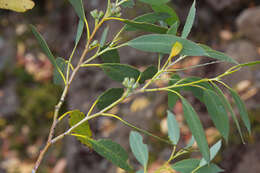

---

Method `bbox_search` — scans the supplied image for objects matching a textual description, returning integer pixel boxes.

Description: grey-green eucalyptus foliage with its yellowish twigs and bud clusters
[31,0,260,173]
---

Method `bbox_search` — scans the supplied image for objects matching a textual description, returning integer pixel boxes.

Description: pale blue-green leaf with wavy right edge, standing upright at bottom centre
[129,131,148,169]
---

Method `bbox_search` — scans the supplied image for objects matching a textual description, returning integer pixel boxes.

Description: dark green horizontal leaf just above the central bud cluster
[101,63,140,82]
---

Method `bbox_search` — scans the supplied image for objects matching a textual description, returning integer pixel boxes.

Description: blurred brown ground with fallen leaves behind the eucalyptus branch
[0,0,260,173]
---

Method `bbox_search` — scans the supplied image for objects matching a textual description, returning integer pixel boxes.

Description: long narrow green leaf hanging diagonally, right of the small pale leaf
[181,97,210,162]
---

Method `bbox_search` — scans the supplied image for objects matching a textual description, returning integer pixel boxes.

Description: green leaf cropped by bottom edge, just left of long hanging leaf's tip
[172,159,200,173]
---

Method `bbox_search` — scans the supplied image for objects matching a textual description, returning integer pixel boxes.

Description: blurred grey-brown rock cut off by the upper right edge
[236,6,260,44]
